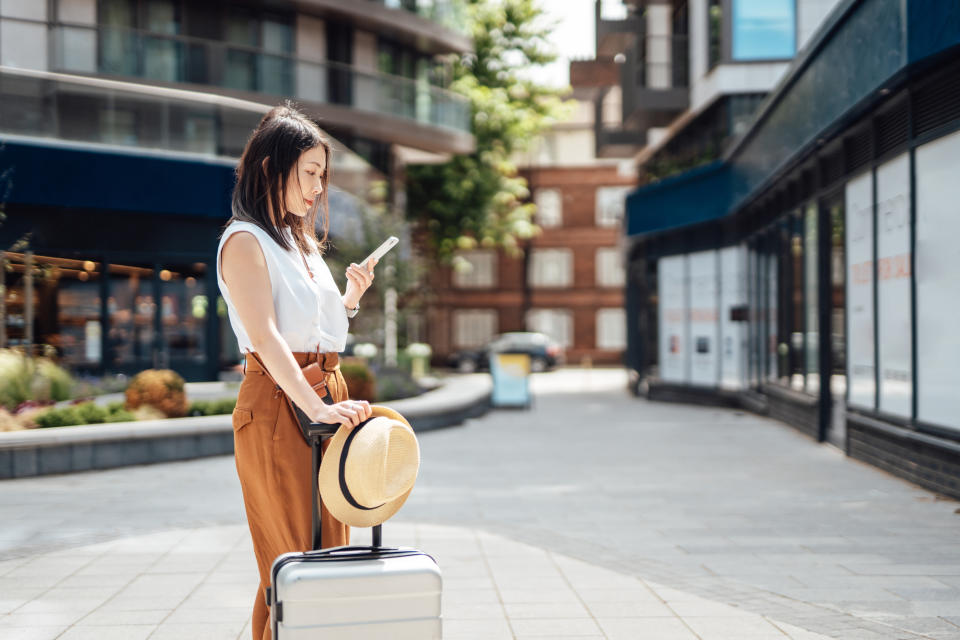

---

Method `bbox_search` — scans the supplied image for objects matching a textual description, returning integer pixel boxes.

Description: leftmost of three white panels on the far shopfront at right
[657,255,688,382]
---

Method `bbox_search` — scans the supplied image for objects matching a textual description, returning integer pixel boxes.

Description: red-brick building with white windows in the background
[427,101,636,364]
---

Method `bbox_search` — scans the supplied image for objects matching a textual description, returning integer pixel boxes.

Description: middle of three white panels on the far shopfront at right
[689,251,720,387]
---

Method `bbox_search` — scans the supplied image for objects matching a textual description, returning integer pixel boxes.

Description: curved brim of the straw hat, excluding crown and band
[318,405,413,527]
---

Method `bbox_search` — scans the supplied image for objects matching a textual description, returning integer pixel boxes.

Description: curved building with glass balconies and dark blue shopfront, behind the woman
[0,0,474,380]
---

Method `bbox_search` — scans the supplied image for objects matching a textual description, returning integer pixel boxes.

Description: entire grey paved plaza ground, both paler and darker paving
[0,369,960,640]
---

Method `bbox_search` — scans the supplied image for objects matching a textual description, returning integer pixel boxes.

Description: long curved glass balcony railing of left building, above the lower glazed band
[53,25,470,132]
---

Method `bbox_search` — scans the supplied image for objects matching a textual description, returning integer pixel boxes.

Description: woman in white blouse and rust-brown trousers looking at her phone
[217,102,375,640]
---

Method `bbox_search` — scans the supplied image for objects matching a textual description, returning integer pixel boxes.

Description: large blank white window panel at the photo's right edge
[915,132,960,430]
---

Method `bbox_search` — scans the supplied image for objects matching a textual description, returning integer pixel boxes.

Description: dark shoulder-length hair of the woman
[227,100,333,254]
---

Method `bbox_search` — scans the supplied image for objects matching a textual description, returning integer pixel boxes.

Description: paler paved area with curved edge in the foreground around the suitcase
[0,524,825,640]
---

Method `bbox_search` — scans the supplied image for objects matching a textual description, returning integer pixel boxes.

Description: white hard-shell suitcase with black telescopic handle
[267,412,443,640]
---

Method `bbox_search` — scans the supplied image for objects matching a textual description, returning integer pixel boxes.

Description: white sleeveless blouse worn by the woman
[217,220,349,353]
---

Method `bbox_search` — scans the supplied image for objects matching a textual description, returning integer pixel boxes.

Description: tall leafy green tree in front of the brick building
[407,0,576,261]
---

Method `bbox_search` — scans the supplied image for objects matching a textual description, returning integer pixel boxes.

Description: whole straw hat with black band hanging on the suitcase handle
[319,406,420,527]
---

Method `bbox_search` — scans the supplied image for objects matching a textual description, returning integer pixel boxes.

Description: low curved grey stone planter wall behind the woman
[0,374,492,479]
